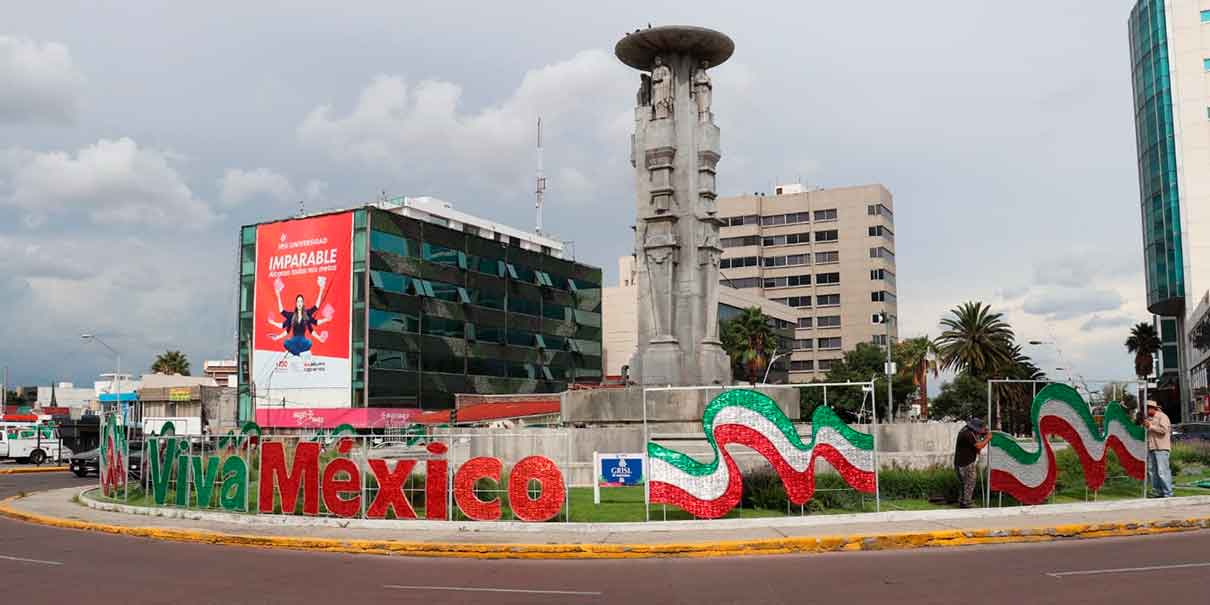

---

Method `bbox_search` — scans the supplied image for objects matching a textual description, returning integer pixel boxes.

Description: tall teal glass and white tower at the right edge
[1129,0,1210,419]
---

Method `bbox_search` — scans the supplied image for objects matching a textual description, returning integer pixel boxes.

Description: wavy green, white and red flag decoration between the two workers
[989,385,1147,505]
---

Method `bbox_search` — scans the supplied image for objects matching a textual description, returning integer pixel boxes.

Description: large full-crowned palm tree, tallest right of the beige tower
[937,303,1013,379]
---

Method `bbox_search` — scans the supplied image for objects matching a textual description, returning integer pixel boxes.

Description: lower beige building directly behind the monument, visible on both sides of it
[601,257,799,384]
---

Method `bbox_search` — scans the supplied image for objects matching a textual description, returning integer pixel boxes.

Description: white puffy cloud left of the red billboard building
[0,138,217,230]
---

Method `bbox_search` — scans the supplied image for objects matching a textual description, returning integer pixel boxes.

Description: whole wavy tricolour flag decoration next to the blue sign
[647,390,875,519]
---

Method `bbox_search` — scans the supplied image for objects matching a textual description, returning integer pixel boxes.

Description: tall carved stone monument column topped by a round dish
[613,25,736,385]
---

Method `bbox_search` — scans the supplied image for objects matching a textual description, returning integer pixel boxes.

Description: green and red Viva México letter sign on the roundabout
[146,437,566,522]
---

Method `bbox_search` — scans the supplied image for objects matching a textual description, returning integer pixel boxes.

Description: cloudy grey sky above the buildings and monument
[0,0,1147,385]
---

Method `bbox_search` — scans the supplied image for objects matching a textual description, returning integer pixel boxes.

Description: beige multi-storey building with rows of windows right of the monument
[719,185,898,382]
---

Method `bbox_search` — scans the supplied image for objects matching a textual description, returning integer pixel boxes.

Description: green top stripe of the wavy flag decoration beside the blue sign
[647,388,874,477]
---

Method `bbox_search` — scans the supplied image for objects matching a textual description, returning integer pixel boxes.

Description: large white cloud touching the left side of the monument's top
[296,51,638,201]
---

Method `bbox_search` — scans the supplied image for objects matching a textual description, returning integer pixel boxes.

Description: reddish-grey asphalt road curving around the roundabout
[0,472,1210,605]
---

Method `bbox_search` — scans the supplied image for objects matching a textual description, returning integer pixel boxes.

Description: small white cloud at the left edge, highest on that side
[0,35,83,123]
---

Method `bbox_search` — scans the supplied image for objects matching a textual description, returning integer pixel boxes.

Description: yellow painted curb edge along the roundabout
[0,496,1210,559]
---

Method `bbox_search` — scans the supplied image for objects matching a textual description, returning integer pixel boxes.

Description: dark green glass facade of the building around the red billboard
[238,207,601,419]
